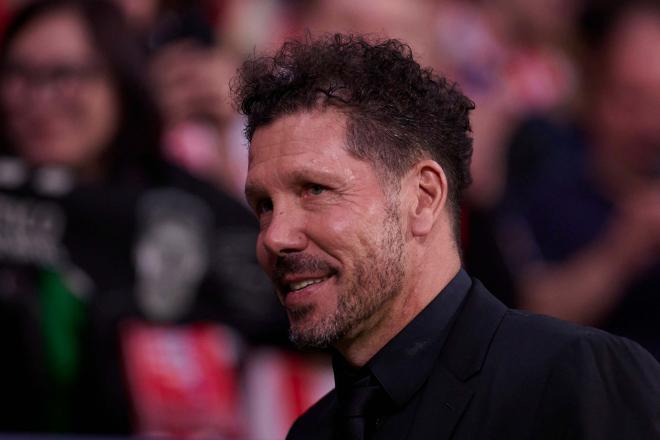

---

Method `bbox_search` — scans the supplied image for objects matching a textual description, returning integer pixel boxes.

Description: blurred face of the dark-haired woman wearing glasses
[0,9,119,175]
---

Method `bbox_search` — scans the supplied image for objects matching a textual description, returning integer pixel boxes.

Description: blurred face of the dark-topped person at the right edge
[592,11,660,178]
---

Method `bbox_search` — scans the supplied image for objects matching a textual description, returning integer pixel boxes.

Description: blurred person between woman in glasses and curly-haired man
[115,0,256,202]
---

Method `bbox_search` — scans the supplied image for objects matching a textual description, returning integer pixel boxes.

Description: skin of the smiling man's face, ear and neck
[246,110,460,366]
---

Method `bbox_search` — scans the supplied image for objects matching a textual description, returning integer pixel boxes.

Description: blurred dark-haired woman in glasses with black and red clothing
[0,0,285,435]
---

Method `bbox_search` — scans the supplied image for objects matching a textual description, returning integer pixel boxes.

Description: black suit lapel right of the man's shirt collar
[409,280,507,440]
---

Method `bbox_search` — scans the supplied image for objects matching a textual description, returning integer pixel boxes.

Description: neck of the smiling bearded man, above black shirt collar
[335,248,461,368]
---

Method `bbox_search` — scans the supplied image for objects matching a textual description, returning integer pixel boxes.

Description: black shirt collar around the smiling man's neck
[333,269,472,406]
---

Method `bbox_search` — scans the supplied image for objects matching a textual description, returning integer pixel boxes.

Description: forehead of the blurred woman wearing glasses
[9,9,93,62]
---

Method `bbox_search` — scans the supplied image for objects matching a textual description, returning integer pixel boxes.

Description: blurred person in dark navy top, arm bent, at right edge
[492,0,660,359]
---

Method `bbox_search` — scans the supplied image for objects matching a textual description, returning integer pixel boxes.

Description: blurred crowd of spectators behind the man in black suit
[0,0,660,440]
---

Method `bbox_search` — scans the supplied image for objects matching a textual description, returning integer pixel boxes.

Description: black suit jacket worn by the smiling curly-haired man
[287,280,660,440]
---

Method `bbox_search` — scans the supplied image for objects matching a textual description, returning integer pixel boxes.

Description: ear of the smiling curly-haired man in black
[410,159,448,237]
